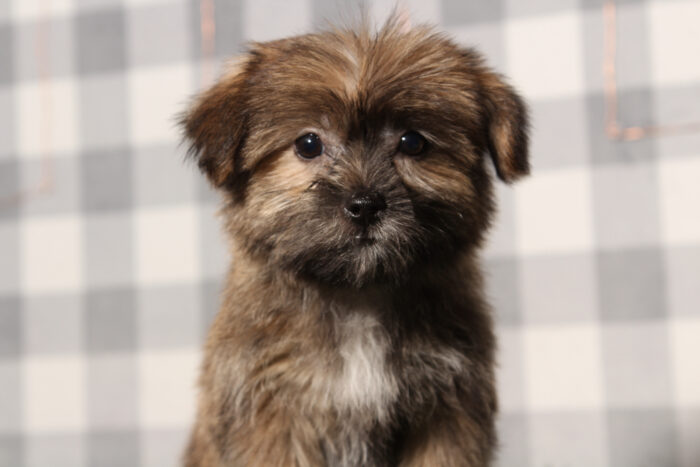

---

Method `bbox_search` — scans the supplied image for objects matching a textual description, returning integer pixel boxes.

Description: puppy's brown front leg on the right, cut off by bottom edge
[399,410,494,467]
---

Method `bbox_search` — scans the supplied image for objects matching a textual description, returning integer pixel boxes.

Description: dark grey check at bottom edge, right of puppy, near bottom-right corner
[608,408,678,467]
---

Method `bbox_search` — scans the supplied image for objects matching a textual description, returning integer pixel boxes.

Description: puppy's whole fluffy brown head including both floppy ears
[183,24,528,286]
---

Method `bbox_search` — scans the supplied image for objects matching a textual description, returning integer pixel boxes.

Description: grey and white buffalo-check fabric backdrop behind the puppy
[0,0,700,467]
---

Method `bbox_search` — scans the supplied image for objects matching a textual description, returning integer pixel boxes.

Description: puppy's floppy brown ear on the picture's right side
[482,71,530,183]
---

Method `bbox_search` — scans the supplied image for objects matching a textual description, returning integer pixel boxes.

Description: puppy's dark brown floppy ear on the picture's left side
[180,57,252,187]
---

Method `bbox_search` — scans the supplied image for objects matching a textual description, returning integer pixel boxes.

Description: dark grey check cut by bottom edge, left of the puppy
[88,431,140,467]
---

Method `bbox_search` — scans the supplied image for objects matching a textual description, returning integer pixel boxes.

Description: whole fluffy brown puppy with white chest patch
[182,16,528,467]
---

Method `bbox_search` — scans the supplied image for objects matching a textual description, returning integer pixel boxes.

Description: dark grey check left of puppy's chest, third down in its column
[85,288,136,352]
